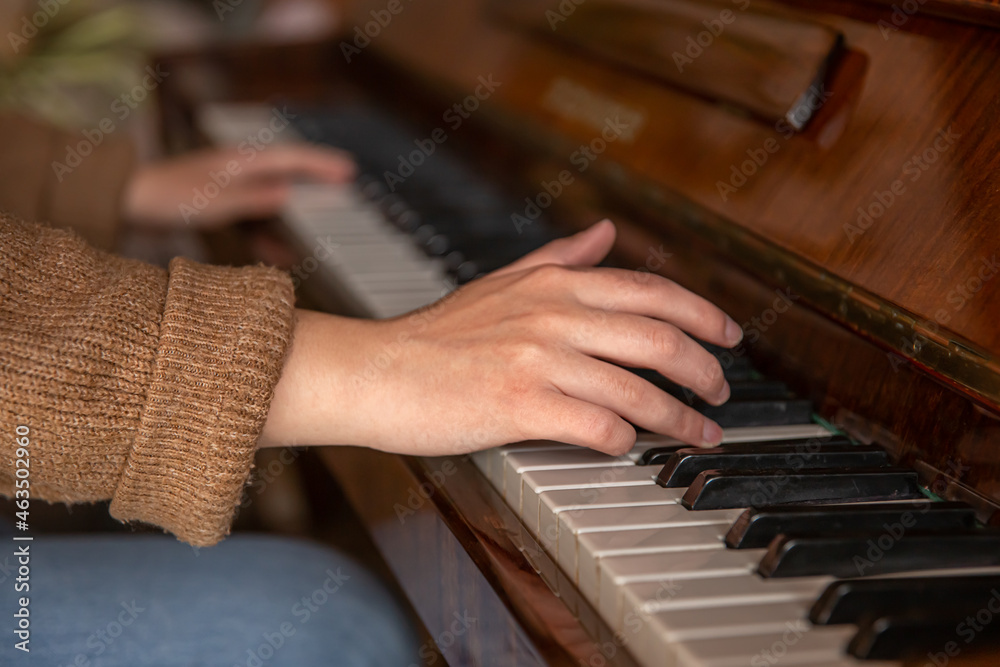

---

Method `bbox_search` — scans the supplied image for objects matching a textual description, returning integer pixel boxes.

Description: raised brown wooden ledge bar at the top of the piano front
[490,0,841,129]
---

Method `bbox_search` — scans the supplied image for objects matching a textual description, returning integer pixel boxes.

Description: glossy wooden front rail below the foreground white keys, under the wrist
[320,447,636,667]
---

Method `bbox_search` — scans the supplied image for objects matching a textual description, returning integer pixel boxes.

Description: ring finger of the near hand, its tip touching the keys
[551,357,722,447]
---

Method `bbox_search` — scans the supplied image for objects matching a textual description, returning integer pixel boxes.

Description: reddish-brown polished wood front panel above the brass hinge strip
[354,0,1000,384]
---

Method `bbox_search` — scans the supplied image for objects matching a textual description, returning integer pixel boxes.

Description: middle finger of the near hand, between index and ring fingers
[566,313,729,405]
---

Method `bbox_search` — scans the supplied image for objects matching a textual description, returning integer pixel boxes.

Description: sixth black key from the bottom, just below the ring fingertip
[656,442,889,489]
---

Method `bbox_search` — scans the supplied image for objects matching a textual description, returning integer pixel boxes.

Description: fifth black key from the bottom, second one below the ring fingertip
[681,467,924,510]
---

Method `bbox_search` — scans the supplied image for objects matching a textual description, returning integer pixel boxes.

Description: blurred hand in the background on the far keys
[122,144,355,228]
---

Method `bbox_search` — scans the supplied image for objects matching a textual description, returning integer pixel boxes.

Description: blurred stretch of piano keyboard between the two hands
[284,105,556,317]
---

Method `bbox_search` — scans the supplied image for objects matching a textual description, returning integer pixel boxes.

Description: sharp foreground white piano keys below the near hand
[473,424,1000,667]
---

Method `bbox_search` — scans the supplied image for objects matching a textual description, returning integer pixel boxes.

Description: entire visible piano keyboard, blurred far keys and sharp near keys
[205,103,1000,667]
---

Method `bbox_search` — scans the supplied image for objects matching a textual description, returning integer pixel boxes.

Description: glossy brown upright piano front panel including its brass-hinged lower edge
[359,0,1000,411]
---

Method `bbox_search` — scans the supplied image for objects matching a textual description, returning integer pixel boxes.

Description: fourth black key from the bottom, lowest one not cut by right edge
[726,500,976,549]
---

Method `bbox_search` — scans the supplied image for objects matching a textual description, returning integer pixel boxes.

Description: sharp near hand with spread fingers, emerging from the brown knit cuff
[261,221,742,455]
